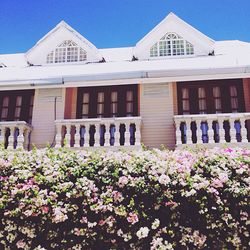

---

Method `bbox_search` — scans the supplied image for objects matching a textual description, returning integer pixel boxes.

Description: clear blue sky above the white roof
[0,0,250,54]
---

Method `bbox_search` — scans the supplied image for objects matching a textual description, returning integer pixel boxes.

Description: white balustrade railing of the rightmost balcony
[174,113,250,147]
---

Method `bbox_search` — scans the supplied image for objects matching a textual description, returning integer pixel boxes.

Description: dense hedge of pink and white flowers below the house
[0,148,250,249]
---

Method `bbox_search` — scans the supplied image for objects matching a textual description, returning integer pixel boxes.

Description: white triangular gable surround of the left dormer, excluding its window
[26,21,102,65]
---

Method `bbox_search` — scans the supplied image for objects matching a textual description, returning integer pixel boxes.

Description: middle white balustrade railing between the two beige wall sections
[55,117,141,148]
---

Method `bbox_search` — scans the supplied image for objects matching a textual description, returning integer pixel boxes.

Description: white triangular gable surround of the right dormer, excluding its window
[134,13,214,59]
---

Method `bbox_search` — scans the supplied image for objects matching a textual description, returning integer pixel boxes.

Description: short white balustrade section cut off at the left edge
[0,121,32,149]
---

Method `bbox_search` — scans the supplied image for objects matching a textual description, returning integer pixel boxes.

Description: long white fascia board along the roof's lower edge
[0,67,250,90]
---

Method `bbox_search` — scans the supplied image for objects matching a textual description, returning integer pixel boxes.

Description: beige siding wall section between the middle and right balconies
[140,83,175,149]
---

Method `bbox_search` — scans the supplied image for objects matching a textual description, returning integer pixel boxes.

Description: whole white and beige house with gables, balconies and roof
[0,13,250,149]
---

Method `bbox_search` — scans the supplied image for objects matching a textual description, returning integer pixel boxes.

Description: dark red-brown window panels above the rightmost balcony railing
[177,79,245,114]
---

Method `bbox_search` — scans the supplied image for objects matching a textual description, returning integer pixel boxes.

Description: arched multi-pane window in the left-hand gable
[47,40,87,63]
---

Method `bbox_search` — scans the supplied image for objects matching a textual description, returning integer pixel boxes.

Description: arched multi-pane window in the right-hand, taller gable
[150,33,194,57]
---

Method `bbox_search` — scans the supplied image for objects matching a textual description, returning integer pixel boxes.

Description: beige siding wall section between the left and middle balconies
[31,88,65,148]
